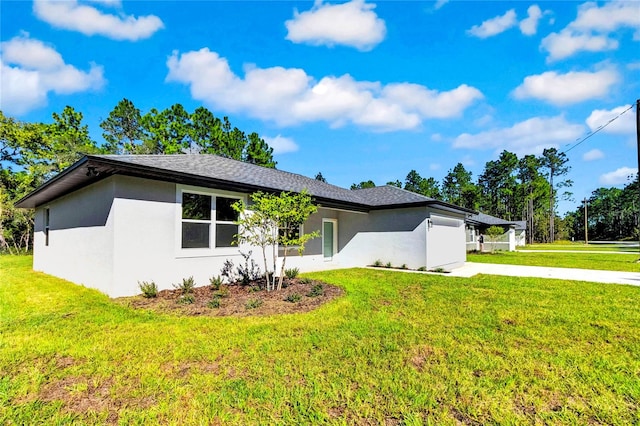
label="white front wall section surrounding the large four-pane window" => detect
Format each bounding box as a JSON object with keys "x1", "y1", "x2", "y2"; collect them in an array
[{"x1": 109, "y1": 176, "x2": 264, "y2": 297}]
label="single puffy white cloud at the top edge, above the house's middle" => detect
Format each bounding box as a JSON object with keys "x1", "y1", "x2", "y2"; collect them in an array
[{"x1": 285, "y1": 0, "x2": 387, "y2": 51}]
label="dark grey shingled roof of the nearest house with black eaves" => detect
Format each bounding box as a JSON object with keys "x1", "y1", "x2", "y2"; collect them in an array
[{"x1": 17, "y1": 154, "x2": 474, "y2": 213}]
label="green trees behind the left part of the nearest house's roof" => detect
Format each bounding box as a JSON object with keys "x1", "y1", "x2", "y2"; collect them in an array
[{"x1": 0, "y1": 99, "x2": 277, "y2": 253}]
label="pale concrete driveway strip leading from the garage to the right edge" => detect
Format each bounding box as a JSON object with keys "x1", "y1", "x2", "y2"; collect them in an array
[{"x1": 447, "y1": 262, "x2": 640, "y2": 286}]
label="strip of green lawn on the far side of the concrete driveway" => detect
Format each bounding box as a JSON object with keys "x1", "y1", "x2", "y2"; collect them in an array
[{"x1": 467, "y1": 251, "x2": 640, "y2": 272}]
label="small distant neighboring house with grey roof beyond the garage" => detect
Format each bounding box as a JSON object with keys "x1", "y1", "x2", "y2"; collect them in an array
[{"x1": 466, "y1": 213, "x2": 527, "y2": 251}]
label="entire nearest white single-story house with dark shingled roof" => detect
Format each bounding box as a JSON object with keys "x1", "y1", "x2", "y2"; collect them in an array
[{"x1": 17, "y1": 155, "x2": 474, "y2": 297}]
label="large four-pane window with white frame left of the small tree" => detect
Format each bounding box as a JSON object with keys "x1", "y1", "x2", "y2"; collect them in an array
[{"x1": 181, "y1": 191, "x2": 238, "y2": 249}]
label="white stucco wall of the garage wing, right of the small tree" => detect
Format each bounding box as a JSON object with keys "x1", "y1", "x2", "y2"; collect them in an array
[{"x1": 287, "y1": 207, "x2": 466, "y2": 271}]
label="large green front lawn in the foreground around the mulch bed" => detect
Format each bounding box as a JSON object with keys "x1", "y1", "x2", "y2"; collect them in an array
[{"x1": 0, "y1": 256, "x2": 640, "y2": 425}]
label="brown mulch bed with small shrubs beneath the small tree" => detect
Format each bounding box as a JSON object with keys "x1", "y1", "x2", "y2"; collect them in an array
[{"x1": 116, "y1": 278, "x2": 344, "y2": 317}]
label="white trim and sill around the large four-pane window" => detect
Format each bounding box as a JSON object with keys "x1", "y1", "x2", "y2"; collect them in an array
[{"x1": 174, "y1": 184, "x2": 247, "y2": 258}]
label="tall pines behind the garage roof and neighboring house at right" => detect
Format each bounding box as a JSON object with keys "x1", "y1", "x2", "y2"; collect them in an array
[{"x1": 351, "y1": 148, "x2": 573, "y2": 243}]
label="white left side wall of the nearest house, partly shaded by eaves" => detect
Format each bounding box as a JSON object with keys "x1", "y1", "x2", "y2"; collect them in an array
[{"x1": 33, "y1": 178, "x2": 115, "y2": 294}]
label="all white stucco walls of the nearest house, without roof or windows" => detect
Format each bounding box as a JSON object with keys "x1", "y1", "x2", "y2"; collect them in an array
[{"x1": 34, "y1": 175, "x2": 466, "y2": 297}]
